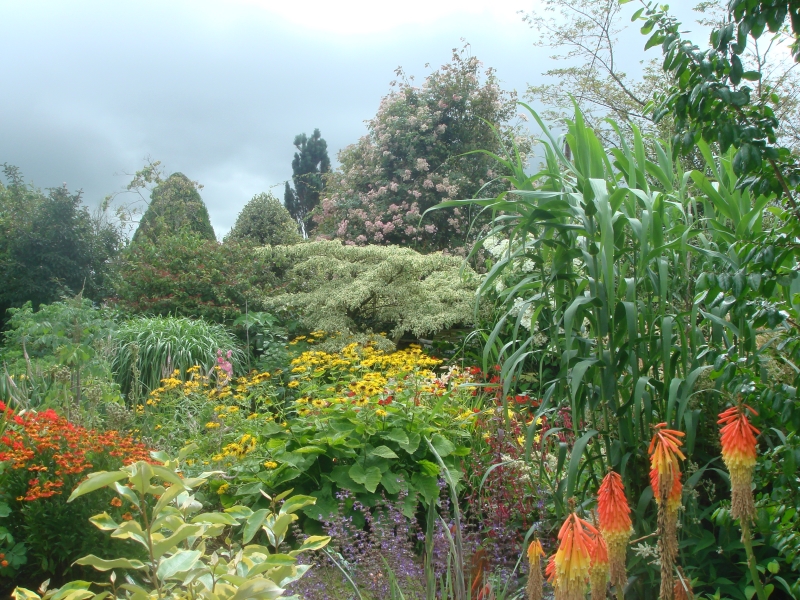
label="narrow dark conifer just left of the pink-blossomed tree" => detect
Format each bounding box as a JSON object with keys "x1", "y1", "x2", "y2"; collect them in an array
[{"x1": 283, "y1": 129, "x2": 331, "y2": 237}]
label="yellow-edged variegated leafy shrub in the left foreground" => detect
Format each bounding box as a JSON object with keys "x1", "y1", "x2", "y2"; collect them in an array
[{"x1": 14, "y1": 452, "x2": 330, "y2": 600}]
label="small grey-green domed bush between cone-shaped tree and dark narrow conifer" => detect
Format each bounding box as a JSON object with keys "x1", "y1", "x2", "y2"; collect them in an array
[{"x1": 225, "y1": 193, "x2": 303, "y2": 246}]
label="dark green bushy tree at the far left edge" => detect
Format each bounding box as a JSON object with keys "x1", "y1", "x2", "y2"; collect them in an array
[{"x1": 0, "y1": 165, "x2": 122, "y2": 320}]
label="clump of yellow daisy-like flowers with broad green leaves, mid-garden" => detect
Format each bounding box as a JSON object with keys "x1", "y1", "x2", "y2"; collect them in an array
[{"x1": 138, "y1": 332, "x2": 477, "y2": 528}]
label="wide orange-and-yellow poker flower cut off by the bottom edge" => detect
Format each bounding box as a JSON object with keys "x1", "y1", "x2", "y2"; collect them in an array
[{"x1": 548, "y1": 513, "x2": 599, "y2": 600}]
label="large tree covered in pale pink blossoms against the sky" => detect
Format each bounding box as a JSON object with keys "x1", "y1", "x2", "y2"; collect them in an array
[{"x1": 313, "y1": 48, "x2": 530, "y2": 253}]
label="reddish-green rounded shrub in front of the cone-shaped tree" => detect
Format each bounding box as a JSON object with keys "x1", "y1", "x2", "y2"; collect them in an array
[{"x1": 111, "y1": 230, "x2": 271, "y2": 322}]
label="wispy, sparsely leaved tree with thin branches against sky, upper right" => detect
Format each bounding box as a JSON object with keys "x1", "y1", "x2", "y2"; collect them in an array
[{"x1": 525, "y1": 0, "x2": 800, "y2": 155}]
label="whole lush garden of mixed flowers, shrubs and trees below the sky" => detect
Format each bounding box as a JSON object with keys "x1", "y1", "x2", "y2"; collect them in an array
[{"x1": 0, "y1": 0, "x2": 800, "y2": 600}]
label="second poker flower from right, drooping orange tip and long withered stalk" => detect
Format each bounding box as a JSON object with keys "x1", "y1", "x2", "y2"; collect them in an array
[{"x1": 648, "y1": 423, "x2": 686, "y2": 600}]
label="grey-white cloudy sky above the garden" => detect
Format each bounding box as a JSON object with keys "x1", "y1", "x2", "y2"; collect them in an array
[{"x1": 0, "y1": 0, "x2": 700, "y2": 238}]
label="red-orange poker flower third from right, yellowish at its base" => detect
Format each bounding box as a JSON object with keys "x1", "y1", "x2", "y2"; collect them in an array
[{"x1": 597, "y1": 471, "x2": 631, "y2": 590}]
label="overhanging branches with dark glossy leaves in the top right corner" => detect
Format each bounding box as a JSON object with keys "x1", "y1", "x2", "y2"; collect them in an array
[{"x1": 634, "y1": 1, "x2": 800, "y2": 200}]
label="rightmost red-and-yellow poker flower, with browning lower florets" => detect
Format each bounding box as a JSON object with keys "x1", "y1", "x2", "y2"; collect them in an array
[{"x1": 717, "y1": 404, "x2": 761, "y2": 521}]
